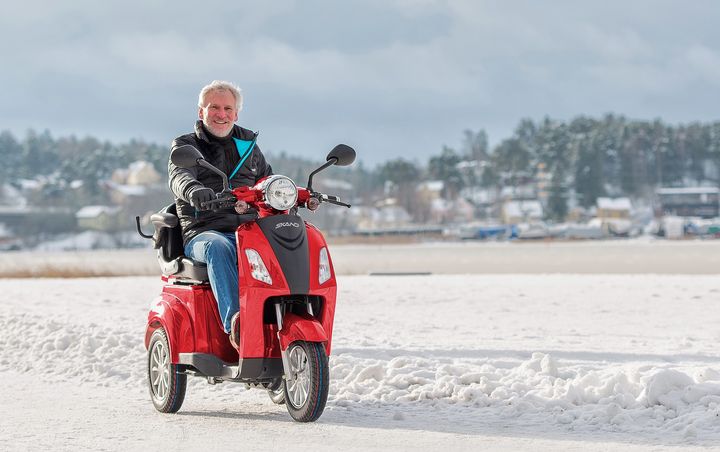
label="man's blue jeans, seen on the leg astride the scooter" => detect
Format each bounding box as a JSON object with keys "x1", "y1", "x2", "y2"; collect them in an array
[{"x1": 185, "y1": 231, "x2": 240, "y2": 333}]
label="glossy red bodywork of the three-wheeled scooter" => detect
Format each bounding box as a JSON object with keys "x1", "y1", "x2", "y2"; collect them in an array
[{"x1": 145, "y1": 222, "x2": 337, "y2": 363}]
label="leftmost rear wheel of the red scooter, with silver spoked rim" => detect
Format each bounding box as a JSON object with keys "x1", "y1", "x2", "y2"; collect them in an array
[{"x1": 147, "y1": 328, "x2": 187, "y2": 413}]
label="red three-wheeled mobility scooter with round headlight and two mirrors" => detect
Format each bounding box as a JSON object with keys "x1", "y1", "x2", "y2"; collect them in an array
[{"x1": 136, "y1": 144, "x2": 355, "y2": 422}]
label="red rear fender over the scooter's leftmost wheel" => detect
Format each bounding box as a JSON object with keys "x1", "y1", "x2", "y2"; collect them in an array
[{"x1": 145, "y1": 293, "x2": 195, "y2": 364}]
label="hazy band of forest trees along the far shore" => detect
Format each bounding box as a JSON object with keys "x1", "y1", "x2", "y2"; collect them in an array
[{"x1": 0, "y1": 115, "x2": 720, "y2": 220}]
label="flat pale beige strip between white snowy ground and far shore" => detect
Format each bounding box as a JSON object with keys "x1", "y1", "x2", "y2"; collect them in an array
[{"x1": 0, "y1": 239, "x2": 720, "y2": 278}]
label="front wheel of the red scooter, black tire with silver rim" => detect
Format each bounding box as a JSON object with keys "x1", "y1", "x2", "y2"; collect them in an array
[{"x1": 283, "y1": 341, "x2": 330, "y2": 422}]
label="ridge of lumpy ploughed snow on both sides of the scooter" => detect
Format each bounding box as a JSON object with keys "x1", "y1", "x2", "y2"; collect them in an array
[{"x1": 0, "y1": 315, "x2": 720, "y2": 439}]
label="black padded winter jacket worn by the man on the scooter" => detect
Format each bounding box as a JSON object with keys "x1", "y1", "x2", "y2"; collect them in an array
[{"x1": 168, "y1": 121, "x2": 272, "y2": 244}]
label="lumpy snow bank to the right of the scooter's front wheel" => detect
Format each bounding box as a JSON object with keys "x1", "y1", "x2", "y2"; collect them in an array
[{"x1": 331, "y1": 353, "x2": 720, "y2": 438}]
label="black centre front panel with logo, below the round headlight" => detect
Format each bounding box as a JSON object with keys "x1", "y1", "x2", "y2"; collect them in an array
[{"x1": 257, "y1": 215, "x2": 310, "y2": 294}]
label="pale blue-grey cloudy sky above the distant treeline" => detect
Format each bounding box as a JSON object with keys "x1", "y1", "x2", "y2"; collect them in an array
[{"x1": 0, "y1": 0, "x2": 720, "y2": 166}]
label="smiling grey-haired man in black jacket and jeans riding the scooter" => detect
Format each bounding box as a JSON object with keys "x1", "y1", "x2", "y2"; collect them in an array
[{"x1": 168, "y1": 80, "x2": 272, "y2": 348}]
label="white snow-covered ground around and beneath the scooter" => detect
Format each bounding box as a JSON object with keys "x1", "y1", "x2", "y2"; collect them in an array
[{"x1": 0, "y1": 273, "x2": 720, "y2": 451}]
